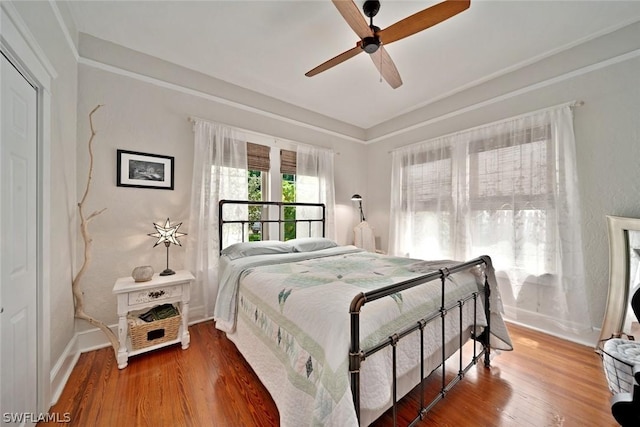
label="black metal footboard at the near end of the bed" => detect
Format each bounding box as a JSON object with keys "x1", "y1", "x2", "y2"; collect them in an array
[{"x1": 349, "y1": 256, "x2": 491, "y2": 426}]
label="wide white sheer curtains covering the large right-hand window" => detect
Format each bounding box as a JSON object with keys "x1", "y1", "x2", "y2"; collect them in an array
[{"x1": 389, "y1": 105, "x2": 591, "y2": 334}]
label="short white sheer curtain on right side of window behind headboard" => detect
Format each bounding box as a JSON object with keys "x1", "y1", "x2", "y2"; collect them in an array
[{"x1": 296, "y1": 145, "x2": 336, "y2": 240}]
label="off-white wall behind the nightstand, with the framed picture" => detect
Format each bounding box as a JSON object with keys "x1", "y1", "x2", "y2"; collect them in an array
[{"x1": 76, "y1": 52, "x2": 366, "y2": 329}]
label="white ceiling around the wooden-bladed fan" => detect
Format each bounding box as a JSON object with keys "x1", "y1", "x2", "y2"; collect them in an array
[{"x1": 63, "y1": 0, "x2": 640, "y2": 129}]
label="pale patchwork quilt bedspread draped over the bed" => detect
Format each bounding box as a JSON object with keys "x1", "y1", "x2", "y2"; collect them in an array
[{"x1": 216, "y1": 248, "x2": 510, "y2": 426}]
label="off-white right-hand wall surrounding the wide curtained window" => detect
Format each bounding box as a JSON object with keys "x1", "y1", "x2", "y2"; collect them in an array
[{"x1": 367, "y1": 24, "x2": 640, "y2": 344}]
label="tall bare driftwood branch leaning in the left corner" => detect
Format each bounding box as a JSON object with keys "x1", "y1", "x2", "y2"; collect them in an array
[{"x1": 71, "y1": 105, "x2": 120, "y2": 356}]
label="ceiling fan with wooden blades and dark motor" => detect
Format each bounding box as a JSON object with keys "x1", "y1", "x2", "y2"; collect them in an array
[{"x1": 305, "y1": 0, "x2": 471, "y2": 89}]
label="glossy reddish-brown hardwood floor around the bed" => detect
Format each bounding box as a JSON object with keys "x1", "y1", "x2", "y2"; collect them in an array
[{"x1": 38, "y1": 322, "x2": 617, "y2": 427}]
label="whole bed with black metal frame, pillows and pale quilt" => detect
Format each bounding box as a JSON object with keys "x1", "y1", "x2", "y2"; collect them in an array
[{"x1": 214, "y1": 200, "x2": 512, "y2": 426}]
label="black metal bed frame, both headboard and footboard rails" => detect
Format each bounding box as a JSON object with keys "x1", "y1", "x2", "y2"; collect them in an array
[{"x1": 218, "y1": 200, "x2": 491, "y2": 426}]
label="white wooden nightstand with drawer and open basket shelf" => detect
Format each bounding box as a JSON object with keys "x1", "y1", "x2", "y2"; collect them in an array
[{"x1": 113, "y1": 270, "x2": 194, "y2": 369}]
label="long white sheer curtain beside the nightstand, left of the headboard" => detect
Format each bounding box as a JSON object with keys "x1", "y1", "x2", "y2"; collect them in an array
[{"x1": 186, "y1": 120, "x2": 248, "y2": 317}]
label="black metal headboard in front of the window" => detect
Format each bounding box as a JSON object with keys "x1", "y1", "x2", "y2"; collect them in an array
[{"x1": 218, "y1": 200, "x2": 326, "y2": 250}]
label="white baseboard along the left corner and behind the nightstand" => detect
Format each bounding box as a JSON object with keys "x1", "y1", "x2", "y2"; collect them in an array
[{"x1": 49, "y1": 306, "x2": 211, "y2": 406}]
